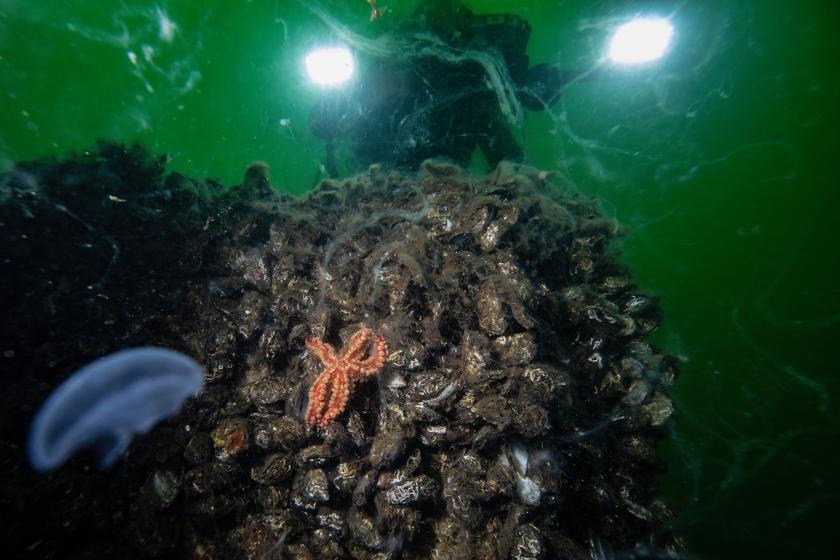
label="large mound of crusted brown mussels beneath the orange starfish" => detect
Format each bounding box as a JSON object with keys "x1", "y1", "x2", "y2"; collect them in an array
[{"x1": 0, "y1": 145, "x2": 681, "y2": 560}]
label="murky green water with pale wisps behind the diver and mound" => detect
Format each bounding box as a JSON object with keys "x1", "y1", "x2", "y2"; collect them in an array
[{"x1": 0, "y1": 0, "x2": 840, "y2": 558}]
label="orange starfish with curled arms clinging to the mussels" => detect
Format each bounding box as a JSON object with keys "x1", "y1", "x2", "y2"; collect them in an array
[{"x1": 306, "y1": 327, "x2": 388, "y2": 428}]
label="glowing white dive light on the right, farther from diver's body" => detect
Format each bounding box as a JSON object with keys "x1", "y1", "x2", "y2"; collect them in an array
[{"x1": 607, "y1": 18, "x2": 674, "y2": 64}]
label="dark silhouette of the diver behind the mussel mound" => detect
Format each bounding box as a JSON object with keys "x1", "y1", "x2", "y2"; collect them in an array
[{"x1": 309, "y1": 0, "x2": 584, "y2": 177}]
